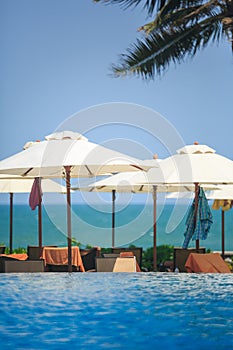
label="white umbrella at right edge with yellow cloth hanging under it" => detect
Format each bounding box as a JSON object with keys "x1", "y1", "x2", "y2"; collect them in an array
[{"x1": 207, "y1": 185, "x2": 233, "y2": 258}]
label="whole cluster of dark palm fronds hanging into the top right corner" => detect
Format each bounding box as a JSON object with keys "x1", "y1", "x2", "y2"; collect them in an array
[{"x1": 96, "y1": 0, "x2": 233, "y2": 79}]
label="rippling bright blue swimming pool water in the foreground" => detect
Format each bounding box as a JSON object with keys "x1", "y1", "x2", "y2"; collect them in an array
[{"x1": 0, "y1": 272, "x2": 233, "y2": 350}]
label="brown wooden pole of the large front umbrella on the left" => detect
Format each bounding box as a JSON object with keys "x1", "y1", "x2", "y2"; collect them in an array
[{"x1": 65, "y1": 166, "x2": 72, "y2": 272}]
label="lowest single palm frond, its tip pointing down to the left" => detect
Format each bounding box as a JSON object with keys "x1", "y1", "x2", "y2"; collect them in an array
[{"x1": 112, "y1": 16, "x2": 222, "y2": 79}]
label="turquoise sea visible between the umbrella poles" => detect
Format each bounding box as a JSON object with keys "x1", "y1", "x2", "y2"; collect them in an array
[{"x1": 0, "y1": 204, "x2": 233, "y2": 251}]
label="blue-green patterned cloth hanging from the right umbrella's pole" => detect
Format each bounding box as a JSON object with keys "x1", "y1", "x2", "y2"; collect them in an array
[{"x1": 183, "y1": 188, "x2": 213, "y2": 249}]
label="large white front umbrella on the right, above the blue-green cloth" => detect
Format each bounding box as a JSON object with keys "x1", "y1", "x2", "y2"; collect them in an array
[{"x1": 141, "y1": 143, "x2": 233, "y2": 253}]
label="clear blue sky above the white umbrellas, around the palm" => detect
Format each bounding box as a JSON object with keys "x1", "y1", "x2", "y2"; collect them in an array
[{"x1": 0, "y1": 0, "x2": 233, "y2": 205}]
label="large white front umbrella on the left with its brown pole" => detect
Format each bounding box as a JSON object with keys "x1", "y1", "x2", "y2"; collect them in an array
[{"x1": 0, "y1": 131, "x2": 150, "y2": 272}]
